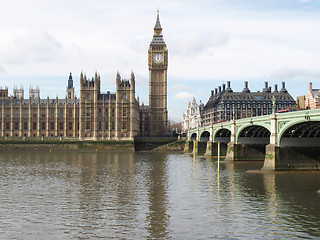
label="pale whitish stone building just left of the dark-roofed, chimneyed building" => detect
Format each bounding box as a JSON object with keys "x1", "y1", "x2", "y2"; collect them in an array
[{"x1": 182, "y1": 97, "x2": 203, "y2": 133}]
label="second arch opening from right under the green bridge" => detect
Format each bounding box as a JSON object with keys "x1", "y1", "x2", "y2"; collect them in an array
[{"x1": 236, "y1": 124, "x2": 271, "y2": 145}]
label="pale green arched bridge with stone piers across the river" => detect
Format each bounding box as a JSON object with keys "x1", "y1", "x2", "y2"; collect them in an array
[{"x1": 186, "y1": 109, "x2": 320, "y2": 170}]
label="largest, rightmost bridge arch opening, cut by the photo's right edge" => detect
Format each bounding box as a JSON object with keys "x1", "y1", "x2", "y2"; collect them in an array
[{"x1": 278, "y1": 119, "x2": 320, "y2": 147}]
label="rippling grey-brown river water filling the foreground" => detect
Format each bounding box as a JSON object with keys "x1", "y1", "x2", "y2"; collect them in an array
[{"x1": 0, "y1": 152, "x2": 320, "y2": 240}]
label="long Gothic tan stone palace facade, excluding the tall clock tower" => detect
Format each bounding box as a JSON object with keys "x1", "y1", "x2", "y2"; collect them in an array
[{"x1": 0, "y1": 70, "x2": 140, "y2": 140}]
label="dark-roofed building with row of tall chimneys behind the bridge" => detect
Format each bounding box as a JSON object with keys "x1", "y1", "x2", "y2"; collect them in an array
[{"x1": 202, "y1": 81, "x2": 296, "y2": 125}]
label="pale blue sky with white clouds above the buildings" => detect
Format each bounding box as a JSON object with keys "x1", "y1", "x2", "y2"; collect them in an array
[{"x1": 0, "y1": 0, "x2": 320, "y2": 122}]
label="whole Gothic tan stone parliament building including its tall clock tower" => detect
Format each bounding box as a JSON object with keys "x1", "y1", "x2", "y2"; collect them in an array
[{"x1": 0, "y1": 12, "x2": 168, "y2": 140}]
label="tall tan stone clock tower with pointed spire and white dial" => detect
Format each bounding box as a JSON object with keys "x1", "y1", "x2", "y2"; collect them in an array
[{"x1": 148, "y1": 10, "x2": 168, "y2": 137}]
